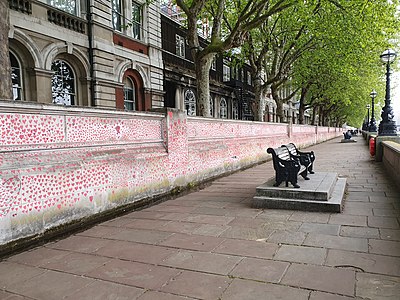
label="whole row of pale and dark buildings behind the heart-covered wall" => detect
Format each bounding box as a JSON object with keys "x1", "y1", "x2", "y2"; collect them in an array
[{"x1": 8, "y1": 0, "x2": 310, "y2": 123}]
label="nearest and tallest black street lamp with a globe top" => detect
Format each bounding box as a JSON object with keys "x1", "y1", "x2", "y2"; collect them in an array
[{"x1": 378, "y1": 49, "x2": 397, "y2": 136}]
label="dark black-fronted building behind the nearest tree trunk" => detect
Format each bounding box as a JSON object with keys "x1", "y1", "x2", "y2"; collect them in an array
[{"x1": 161, "y1": 11, "x2": 254, "y2": 120}]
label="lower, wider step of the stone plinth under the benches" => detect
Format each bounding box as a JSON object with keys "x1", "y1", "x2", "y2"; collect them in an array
[{"x1": 252, "y1": 178, "x2": 346, "y2": 213}]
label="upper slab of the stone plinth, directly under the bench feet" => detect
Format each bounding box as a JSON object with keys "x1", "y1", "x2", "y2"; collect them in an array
[{"x1": 256, "y1": 172, "x2": 338, "y2": 201}]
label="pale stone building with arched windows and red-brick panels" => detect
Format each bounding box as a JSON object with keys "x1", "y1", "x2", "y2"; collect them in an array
[{"x1": 9, "y1": 0, "x2": 163, "y2": 111}]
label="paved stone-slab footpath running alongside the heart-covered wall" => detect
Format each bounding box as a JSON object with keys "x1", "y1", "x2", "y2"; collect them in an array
[{"x1": 0, "y1": 138, "x2": 400, "y2": 300}]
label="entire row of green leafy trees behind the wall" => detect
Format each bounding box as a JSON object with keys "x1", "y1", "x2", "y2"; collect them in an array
[{"x1": 176, "y1": 0, "x2": 399, "y2": 126}]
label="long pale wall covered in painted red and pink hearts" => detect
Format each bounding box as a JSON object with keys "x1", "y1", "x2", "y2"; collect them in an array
[{"x1": 0, "y1": 103, "x2": 342, "y2": 245}]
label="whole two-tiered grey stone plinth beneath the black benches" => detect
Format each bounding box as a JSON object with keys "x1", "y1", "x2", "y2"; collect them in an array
[{"x1": 252, "y1": 172, "x2": 346, "y2": 212}]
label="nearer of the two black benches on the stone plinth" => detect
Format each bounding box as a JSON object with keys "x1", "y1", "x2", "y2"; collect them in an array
[{"x1": 267, "y1": 147, "x2": 309, "y2": 188}]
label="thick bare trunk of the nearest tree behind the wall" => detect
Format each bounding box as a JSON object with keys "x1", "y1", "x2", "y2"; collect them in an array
[{"x1": 195, "y1": 54, "x2": 214, "y2": 117}]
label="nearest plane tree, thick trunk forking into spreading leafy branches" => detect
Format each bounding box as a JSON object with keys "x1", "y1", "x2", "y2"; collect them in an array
[{"x1": 176, "y1": 0, "x2": 297, "y2": 117}]
